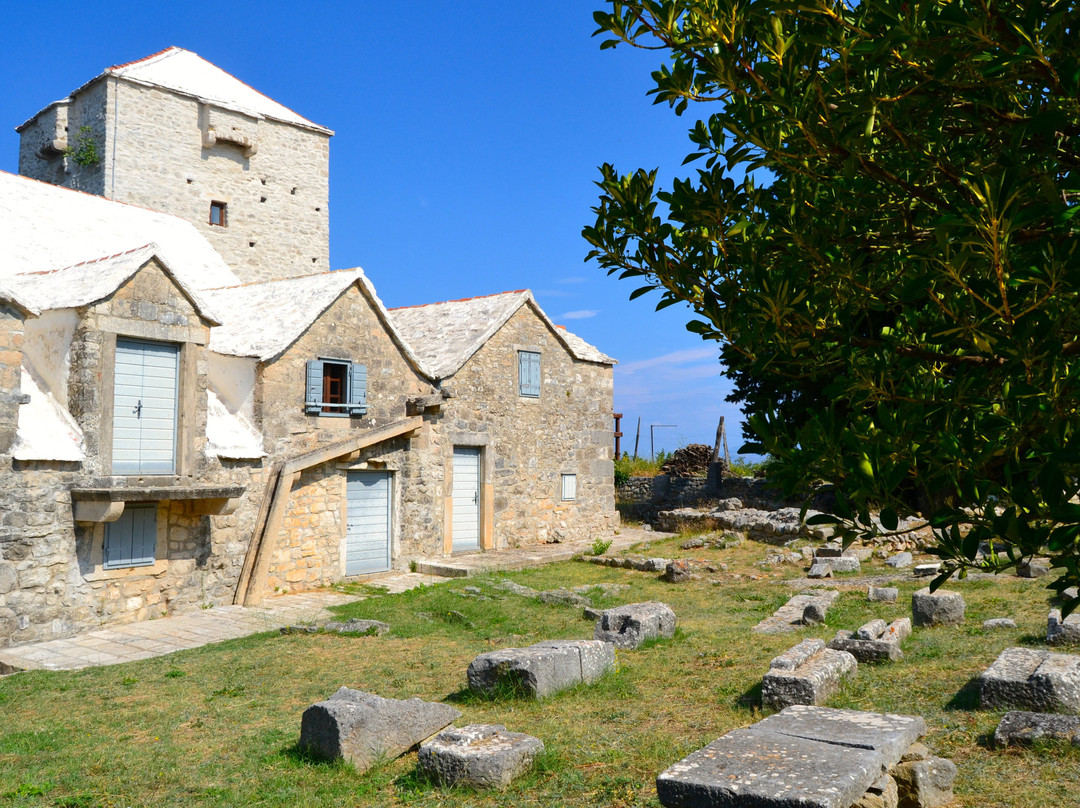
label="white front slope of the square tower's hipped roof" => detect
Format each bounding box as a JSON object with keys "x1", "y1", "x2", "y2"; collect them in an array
[{"x1": 105, "y1": 48, "x2": 333, "y2": 134}]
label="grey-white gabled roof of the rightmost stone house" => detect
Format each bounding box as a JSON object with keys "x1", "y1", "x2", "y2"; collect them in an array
[{"x1": 390, "y1": 289, "x2": 616, "y2": 379}]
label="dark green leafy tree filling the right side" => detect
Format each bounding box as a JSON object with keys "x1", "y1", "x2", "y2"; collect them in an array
[{"x1": 583, "y1": 0, "x2": 1080, "y2": 608}]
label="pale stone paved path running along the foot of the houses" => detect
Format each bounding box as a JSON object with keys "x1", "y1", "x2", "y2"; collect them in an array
[{"x1": 0, "y1": 528, "x2": 667, "y2": 675}]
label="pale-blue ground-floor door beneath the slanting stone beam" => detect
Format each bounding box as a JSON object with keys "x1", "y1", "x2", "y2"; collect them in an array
[{"x1": 345, "y1": 471, "x2": 392, "y2": 575}]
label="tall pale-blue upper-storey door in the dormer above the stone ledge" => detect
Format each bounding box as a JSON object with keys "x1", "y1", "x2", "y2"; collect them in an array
[{"x1": 112, "y1": 339, "x2": 180, "y2": 474}]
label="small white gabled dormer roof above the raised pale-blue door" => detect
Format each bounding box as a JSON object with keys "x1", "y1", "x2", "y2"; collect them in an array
[{"x1": 0, "y1": 244, "x2": 220, "y2": 325}]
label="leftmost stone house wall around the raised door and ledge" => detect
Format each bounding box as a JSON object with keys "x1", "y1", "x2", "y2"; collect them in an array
[{"x1": 0, "y1": 261, "x2": 255, "y2": 646}]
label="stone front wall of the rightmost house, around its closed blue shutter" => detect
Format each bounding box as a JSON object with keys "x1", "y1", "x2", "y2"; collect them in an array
[{"x1": 441, "y1": 306, "x2": 618, "y2": 549}]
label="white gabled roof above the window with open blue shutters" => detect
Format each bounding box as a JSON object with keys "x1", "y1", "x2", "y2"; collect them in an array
[{"x1": 206, "y1": 267, "x2": 428, "y2": 375}]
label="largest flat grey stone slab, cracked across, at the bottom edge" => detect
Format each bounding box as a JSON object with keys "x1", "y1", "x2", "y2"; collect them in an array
[{"x1": 657, "y1": 706, "x2": 926, "y2": 808}]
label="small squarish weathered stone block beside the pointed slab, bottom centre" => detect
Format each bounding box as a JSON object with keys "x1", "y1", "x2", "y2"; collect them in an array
[{"x1": 418, "y1": 724, "x2": 543, "y2": 789}]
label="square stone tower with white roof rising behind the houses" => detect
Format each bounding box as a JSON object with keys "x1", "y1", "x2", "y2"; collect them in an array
[{"x1": 17, "y1": 48, "x2": 334, "y2": 282}]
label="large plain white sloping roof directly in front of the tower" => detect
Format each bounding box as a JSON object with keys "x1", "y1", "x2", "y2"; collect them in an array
[{"x1": 0, "y1": 172, "x2": 240, "y2": 289}]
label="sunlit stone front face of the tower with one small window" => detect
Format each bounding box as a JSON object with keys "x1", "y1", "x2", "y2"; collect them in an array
[{"x1": 107, "y1": 82, "x2": 330, "y2": 282}]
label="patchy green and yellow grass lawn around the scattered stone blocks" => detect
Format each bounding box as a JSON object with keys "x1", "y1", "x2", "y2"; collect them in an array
[{"x1": 0, "y1": 540, "x2": 1080, "y2": 808}]
